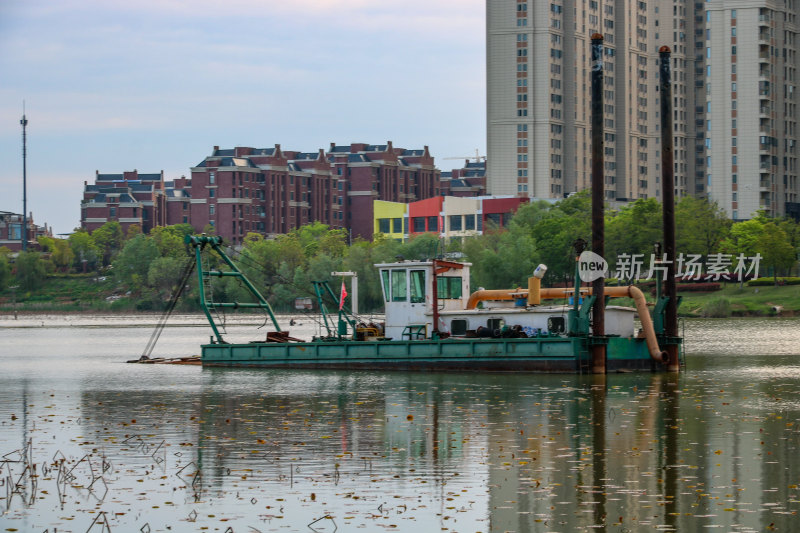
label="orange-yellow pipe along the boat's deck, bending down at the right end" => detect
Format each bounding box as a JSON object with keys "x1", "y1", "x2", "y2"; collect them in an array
[{"x1": 467, "y1": 282, "x2": 667, "y2": 362}]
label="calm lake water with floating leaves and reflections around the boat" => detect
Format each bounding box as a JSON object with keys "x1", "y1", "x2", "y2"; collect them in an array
[{"x1": 0, "y1": 316, "x2": 800, "y2": 533}]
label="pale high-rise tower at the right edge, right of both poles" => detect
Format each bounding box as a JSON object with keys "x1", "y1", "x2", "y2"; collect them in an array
[{"x1": 705, "y1": 0, "x2": 800, "y2": 220}]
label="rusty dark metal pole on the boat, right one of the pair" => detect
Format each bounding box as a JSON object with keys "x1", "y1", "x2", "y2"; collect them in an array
[{"x1": 658, "y1": 46, "x2": 680, "y2": 372}]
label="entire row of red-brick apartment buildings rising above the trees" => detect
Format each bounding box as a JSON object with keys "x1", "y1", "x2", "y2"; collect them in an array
[{"x1": 81, "y1": 141, "x2": 441, "y2": 244}]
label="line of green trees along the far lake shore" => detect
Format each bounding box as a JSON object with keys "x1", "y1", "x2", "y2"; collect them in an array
[{"x1": 0, "y1": 193, "x2": 800, "y2": 312}]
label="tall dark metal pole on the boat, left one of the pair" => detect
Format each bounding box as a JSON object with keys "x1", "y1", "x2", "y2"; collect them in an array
[{"x1": 588, "y1": 33, "x2": 606, "y2": 374}]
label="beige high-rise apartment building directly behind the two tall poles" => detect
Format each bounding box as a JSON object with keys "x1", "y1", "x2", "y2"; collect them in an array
[{"x1": 486, "y1": 0, "x2": 705, "y2": 201}]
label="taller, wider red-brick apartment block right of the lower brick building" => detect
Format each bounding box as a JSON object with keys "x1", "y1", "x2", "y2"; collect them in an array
[{"x1": 189, "y1": 141, "x2": 440, "y2": 243}]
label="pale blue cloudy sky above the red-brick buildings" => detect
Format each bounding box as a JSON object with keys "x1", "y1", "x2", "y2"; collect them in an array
[{"x1": 0, "y1": 0, "x2": 486, "y2": 233}]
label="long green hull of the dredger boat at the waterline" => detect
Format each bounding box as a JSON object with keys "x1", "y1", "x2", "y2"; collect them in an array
[{"x1": 201, "y1": 337, "x2": 662, "y2": 373}]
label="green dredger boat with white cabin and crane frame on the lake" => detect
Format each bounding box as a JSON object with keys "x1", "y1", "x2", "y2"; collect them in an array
[{"x1": 186, "y1": 235, "x2": 682, "y2": 373}]
